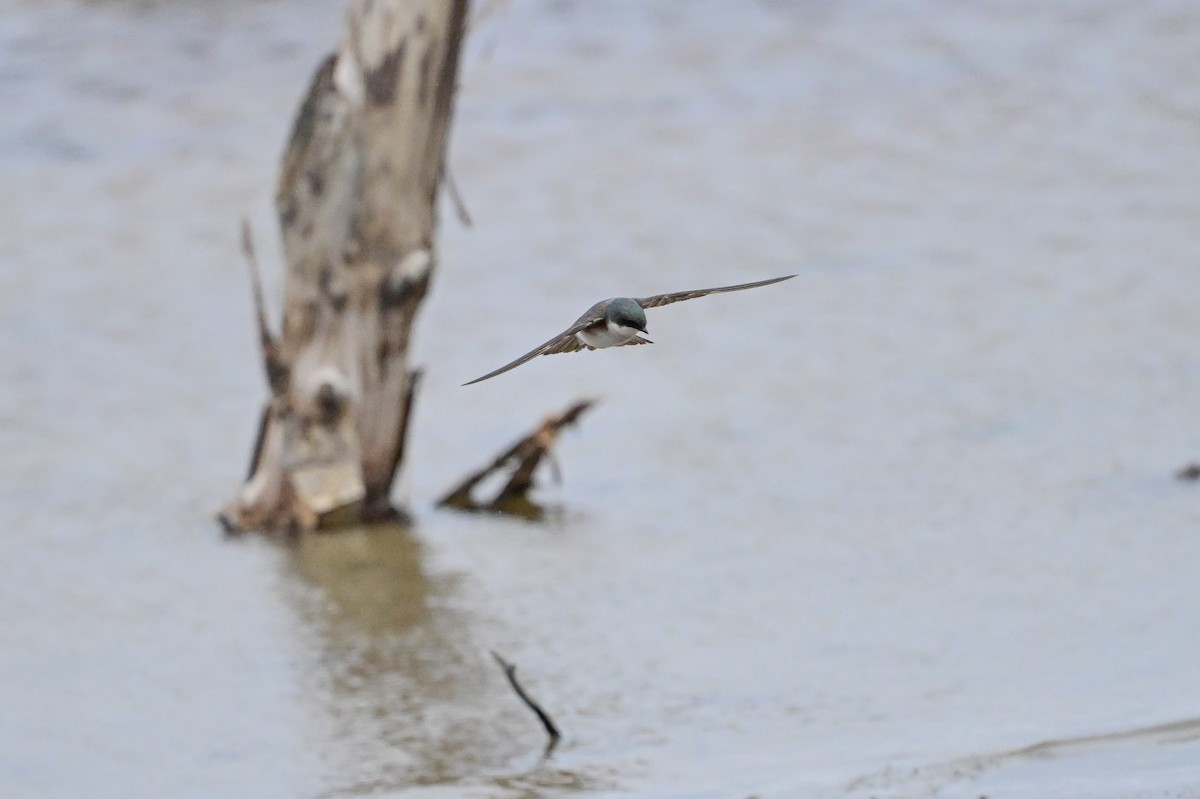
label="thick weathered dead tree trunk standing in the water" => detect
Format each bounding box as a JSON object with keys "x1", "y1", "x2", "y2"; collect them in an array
[{"x1": 221, "y1": 0, "x2": 468, "y2": 530}]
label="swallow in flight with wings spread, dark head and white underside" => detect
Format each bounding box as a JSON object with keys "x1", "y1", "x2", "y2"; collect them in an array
[{"x1": 463, "y1": 275, "x2": 796, "y2": 385}]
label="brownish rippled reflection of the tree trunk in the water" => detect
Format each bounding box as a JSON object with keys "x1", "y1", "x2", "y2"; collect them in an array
[{"x1": 288, "y1": 525, "x2": 526, "y2": 793}]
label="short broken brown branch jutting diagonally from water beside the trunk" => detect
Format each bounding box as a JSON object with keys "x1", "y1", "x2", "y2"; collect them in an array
[{"x1": 438, "y1": 400, "x2": 594, "y2": 521}]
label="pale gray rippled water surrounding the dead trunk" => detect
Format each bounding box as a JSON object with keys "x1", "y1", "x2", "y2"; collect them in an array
[{"x1": 7, "y1": 0, "x2": 1200, "y2": 799}]
